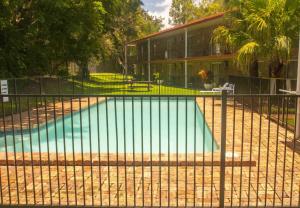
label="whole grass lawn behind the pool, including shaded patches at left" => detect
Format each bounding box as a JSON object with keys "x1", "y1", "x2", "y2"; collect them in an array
[{"x1": 0, "y1": 73, "x2": 216, "y2": 116}]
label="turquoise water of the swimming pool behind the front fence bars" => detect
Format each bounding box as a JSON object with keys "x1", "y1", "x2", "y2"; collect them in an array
[{"x1": 0, "y1": 98, "x2": 218, "y2": 153}]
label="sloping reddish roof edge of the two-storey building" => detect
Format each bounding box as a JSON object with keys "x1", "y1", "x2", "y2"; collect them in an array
[{"x1": 128, "y1": 12, "x2": 225, "y2": 44}]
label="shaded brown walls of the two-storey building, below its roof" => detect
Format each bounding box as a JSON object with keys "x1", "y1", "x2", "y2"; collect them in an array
[{"x1": 135, "y1": 18, "x2": 298, "y2": 88}]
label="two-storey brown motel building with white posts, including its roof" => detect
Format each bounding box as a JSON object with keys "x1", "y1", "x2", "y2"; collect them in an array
[{"x1": 125, "y1": 13, "x2": 298, "y2": 94}]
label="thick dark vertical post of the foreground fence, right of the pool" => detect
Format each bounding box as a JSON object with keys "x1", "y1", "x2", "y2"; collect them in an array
[{"x1": 219, "y1": 91, "x2": 227, "y2": 208}]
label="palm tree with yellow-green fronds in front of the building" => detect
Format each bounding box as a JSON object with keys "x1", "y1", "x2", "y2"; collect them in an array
[{"x1": 213, "y1": 0, "x2": 300, "y2": 77}]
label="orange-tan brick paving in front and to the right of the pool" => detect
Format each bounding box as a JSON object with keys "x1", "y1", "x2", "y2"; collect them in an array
[{"x1": 0, "y1": 98, "x2": 300, "y2": 207}]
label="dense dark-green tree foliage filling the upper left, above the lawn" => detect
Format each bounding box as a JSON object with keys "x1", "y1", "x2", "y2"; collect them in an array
[{"x1": 0, "y1": 0, "x2": 161, "y2": 77}]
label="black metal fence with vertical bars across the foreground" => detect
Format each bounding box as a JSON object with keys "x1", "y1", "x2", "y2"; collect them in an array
[{"x1": 0, "y1": 93, "x2": 300, "y2": 207}]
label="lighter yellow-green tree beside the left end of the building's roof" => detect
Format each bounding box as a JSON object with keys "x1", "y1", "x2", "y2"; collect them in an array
[{"x1": 101, "y1": 0, "x2": 162, "y2": 71}]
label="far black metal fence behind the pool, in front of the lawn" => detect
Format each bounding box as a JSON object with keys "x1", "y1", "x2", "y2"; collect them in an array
[{"x1": 2, "y1": 73, "x2": 199, "y2": 95}]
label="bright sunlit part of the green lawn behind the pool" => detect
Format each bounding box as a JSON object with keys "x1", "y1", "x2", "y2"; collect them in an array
[{"x1": 44, "y1": 73, "x2": 215, "y2": 95}]
